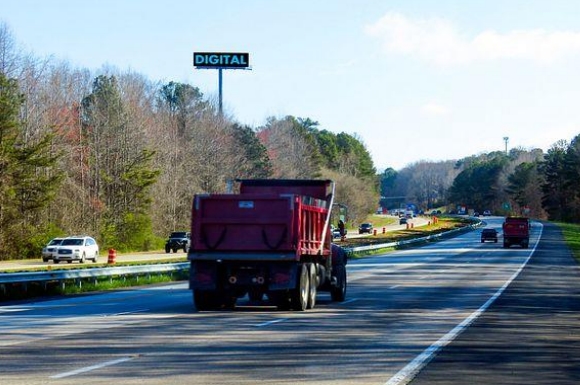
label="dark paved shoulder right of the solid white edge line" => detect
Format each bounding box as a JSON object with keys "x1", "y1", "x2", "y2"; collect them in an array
[{"x1": 412, "y1": 224, "x2": 580, "y2": 385}]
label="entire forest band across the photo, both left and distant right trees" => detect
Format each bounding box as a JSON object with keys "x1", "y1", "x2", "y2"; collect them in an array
[{"x1": 0, "y1": 23, "x2": 580, "y2": 260}]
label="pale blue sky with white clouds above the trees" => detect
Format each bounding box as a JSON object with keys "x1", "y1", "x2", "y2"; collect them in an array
[{"x1": 0, "y1": 0, "x2": 580, "y2": 170}]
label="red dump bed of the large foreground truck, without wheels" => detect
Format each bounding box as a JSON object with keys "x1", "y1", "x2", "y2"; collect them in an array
[{"x1": 190, "y1": 181, "x2": 330, "y2": 260}]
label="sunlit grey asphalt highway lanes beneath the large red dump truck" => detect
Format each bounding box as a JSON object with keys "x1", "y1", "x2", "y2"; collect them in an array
[{"x1": 0, "y1": 218, "x2": 566, "y2": 384}]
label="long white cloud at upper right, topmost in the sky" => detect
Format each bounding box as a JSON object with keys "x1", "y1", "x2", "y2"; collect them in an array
[{"x1": 365, "y1": 12, "x2": 580, "y2": 66}]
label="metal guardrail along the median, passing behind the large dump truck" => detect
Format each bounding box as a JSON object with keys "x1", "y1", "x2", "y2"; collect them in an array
[{"x1": 0, "y1": 222, "x2": 481, "y2": 285}]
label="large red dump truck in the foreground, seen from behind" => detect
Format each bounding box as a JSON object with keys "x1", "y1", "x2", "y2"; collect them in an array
[{"x1": 188, "y1": 179, "x2": 347, "y2": 311}]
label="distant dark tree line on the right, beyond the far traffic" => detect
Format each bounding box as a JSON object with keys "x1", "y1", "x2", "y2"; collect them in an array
[{"x1": 380, "y1": 140, "x2": 580, "y2": 223}]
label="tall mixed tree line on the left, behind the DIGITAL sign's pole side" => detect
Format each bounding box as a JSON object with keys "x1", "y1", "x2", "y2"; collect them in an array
[{"x1": 0, "y1": 23, "x2": 378, "y2": 259}]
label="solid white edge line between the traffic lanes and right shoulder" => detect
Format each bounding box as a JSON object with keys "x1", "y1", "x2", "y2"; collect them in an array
[{"x1": 384, "y1": 223, "x2": 544, "y2": 385}]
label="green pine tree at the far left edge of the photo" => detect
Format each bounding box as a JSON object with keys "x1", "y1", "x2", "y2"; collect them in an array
[{"x1": 0, "y1": 73, "x2": 62, "y2": 259}]
